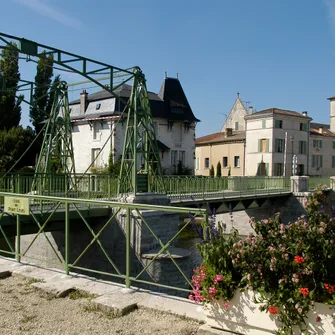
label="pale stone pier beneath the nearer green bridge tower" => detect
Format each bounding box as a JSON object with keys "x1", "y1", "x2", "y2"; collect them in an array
[{"x1": 116, "y1": 193, "x2": 193, "y2": 296}]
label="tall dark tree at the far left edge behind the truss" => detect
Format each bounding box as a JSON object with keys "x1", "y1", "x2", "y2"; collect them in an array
[{"x1": 0, "y1": 43, "x2": 23, "y2": 130}]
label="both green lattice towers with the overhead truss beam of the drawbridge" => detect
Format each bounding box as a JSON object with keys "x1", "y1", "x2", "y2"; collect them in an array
[{"x1": 0, "y1": 33, "x2": 163, "y2": 194}]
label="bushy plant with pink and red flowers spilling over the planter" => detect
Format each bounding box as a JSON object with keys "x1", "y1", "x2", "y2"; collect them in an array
[{"x1": 191, "y1": 187, "x2": 335, "y2": 334}]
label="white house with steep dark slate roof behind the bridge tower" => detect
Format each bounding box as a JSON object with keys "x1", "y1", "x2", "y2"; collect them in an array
[{"x1": 70, "y1": 78, "x2": 199, "y2": 174}]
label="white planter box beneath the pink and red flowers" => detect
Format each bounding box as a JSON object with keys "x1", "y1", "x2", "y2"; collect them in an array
[{"x1": 204, "y1": 291, "x2": 335, "y2": 335}]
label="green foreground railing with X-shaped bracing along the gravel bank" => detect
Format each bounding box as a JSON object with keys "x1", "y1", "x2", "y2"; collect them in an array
[{"x1": 0, "y1": 192, "x2": 208, "y2": 292}]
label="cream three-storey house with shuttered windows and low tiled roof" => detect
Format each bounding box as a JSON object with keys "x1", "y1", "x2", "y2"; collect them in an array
[{"x1": 245, "y1": 109, "x2": 311, "y2": 176}]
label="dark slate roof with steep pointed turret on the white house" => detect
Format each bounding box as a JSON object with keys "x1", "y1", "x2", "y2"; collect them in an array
[{"x1": 69, "y1": 78, "x2": 200, "y2": 122}]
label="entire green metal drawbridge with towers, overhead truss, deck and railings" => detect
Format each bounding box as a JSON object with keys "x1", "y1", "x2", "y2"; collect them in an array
[{"x1": 0, "y1": 33, "x2": 330, "y2": 292}]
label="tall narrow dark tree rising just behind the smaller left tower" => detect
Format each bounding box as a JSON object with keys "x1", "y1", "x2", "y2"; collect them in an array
[{"x1": 29, "y1": 51, "x2": 57, "y2": 134}]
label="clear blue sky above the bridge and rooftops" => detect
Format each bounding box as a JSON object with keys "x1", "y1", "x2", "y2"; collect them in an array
[{"x1": 0, "y1": 0, "x2": 335, "y2": 137}]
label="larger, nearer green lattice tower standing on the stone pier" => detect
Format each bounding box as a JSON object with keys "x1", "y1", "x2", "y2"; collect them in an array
[{"x1": 118, "y1": 67, "x2": 162, "y2": 194}]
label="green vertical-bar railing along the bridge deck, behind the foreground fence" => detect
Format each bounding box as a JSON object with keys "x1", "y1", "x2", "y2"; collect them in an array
[{"x1": 0, "y1": 174, "x2": 296, "y2": 201}]
